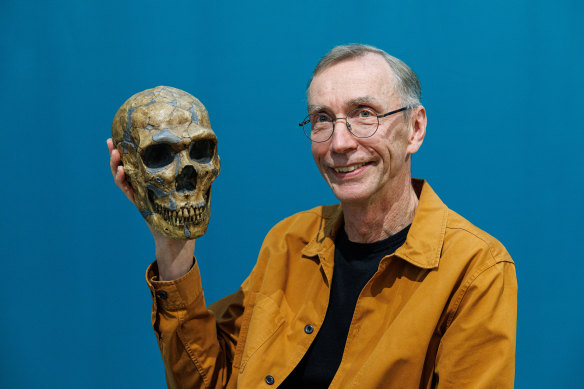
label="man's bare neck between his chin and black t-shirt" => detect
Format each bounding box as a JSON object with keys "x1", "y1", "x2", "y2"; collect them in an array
[{"x1": 343, "y1": 178, "x2": 418, "y2": 243}]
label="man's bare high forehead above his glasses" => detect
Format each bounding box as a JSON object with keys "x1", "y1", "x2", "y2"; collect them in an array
[{"x1": 308, "y1": 53, "x2": 394, "y2": 107}]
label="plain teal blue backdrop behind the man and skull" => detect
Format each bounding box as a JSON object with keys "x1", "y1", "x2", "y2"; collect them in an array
[{"x1": 0, "y1": 0, "x2": 584, "y2": 388}]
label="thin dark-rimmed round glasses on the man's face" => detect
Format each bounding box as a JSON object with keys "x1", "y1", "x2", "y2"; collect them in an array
[{"x1": 298, "y1": 105, "x2": 416, "y2": 143}]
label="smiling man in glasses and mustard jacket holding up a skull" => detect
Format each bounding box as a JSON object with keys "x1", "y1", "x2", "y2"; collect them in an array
[{"x1": 110, "y1": 45, "x2": 517, "y2": 388}]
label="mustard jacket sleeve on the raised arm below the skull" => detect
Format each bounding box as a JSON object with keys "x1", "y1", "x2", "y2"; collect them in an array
[{"x1": 146, "y1": 261, "x2": 247, "y2": 389}]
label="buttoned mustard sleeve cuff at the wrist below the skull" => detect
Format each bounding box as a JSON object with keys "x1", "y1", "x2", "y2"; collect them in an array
[{"x1": 146, "y1": 259, "x2": 203, "y2": 311}]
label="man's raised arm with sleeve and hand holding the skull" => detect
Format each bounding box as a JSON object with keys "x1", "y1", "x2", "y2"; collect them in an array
[{"x1": 107, "y1": 139, "x2": 244, "y2": 388}]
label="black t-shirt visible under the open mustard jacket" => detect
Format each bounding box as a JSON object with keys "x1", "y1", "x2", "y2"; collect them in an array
[{"x1": 279, "y1": 226, "x2": 410, "y2": 389}]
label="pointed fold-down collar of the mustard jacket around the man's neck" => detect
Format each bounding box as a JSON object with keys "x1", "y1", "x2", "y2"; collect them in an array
[{"x1": 302, "y1": 178, "x2": 448, "y2": 269}]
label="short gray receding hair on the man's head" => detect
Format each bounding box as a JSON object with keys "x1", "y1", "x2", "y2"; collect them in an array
[{"x1": 306, "y1": 43, "x2": 422, "y2": 110}]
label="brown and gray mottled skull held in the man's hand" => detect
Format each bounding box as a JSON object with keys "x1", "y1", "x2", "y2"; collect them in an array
[{"x1": 112, "y1": 86, "x2": 220, "y2": 239}]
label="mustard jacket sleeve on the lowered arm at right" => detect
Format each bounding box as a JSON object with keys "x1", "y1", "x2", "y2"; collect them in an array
[{"x1": 434, "y1": 260, "x2": 517, "y2": 389}]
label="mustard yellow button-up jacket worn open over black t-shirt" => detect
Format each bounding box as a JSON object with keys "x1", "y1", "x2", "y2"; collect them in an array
[{"x1": 147, "y1": 180, "x2": 517, "y2": 389}]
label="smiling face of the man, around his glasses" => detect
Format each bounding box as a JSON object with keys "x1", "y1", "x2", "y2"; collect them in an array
[{"x1": 309, "y1": 54, "x2": 425, "y2": 209}]
